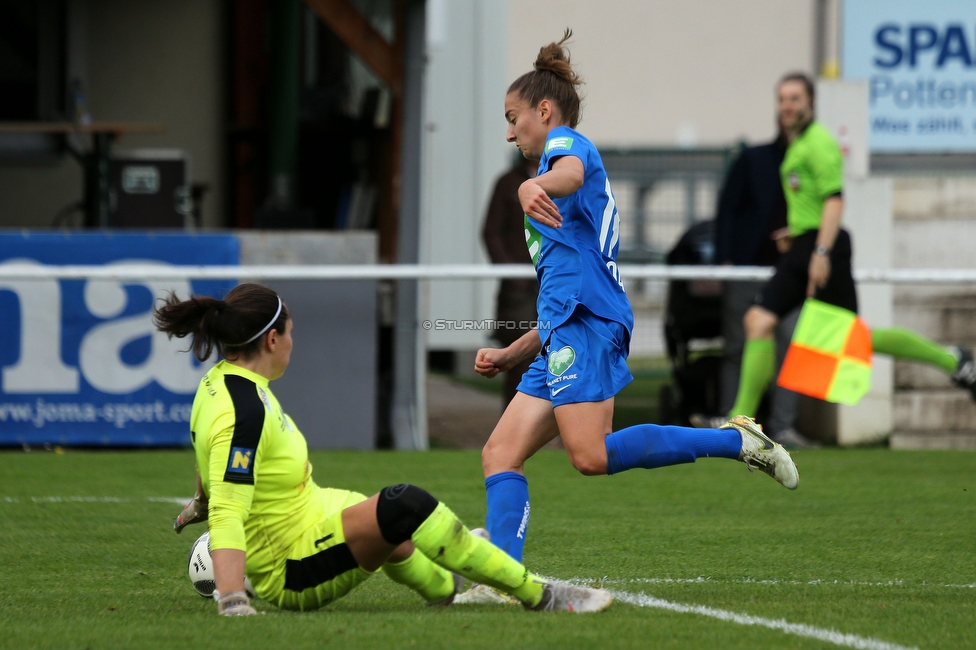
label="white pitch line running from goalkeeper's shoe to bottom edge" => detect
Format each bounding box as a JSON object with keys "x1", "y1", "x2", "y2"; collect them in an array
[{"x1": 610, "y1": 590, "x2": 917, "y2": 650}]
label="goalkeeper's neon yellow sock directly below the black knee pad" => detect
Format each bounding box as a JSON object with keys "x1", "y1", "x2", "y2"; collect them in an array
[{"x1": 411, "y1": 503, "x2": 544, "y2": 607}]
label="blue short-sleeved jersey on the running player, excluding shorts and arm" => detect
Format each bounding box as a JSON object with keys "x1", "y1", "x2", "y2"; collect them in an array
[{"x1": 524, "y1": 126, "x2": 634, "y2": 343}]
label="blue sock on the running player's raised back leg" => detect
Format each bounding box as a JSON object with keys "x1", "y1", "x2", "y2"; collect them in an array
[{"x1": 606, "y1": 424, "x2": 742, "y2": 474}]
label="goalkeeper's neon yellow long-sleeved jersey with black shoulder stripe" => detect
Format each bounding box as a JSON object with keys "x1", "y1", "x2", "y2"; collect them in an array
[{"x1": 190, "y1": 361, "x2": 324, "y2": 584}]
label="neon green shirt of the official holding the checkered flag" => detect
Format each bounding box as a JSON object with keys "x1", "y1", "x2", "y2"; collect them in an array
[{"x1": 779, "y1": 121, "x2": 844, "y2": 237}]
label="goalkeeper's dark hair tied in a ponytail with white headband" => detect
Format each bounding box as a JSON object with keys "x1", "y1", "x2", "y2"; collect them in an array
[{"x1": 153, "y1": 284, "x2": 289, "y2": 361}]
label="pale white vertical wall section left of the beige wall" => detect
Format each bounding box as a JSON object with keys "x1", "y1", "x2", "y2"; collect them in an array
[{"x1": 420, "y1": 0, "x2": 512, "y2": 349}]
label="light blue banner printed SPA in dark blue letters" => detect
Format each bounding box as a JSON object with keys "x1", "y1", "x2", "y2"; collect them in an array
[{"x1": 841, "y1": 0, "x2": 976, "y2": 153}]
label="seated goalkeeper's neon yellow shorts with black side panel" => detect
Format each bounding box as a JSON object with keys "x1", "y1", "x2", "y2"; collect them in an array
[{"x1": 259, "y1": 488, "x2": 373, "y2": 610}]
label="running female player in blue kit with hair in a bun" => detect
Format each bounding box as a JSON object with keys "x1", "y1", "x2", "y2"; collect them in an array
[{"x1": 475, "y1": 30, "x2": 798, "y2": 560}]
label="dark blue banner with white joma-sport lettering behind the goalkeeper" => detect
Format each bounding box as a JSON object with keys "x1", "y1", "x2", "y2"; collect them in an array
[{"x1": 0, "y1": 233, "x2": 239, "y2": 446}]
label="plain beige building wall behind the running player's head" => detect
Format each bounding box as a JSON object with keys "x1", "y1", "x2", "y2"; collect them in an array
[{"x1": 508, "y1": 0, "x2": 816, "y2": 147}]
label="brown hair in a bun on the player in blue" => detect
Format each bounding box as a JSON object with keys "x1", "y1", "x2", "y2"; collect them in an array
[{"x1": 508, "y1": 28, "x2": 583, "y2": 129}]
